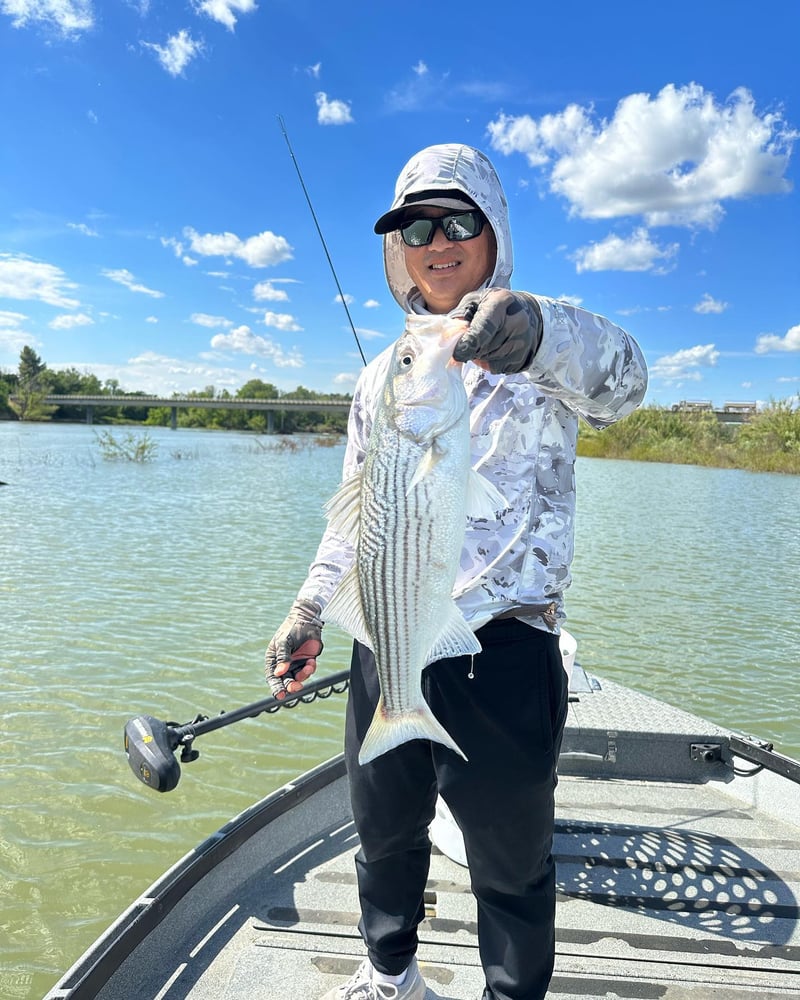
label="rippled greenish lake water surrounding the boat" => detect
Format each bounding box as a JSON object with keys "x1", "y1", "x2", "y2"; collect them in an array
[{"x1": 0, "y1": 423, "x2": 800, "y2": 1000}]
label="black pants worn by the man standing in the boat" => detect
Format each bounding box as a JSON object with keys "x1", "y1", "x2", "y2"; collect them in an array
[{"x1": 345, "y1": 619, "x2": 567, "y2": 1000}]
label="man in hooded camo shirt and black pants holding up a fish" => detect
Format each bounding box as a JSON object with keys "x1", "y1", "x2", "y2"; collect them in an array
[{"x1": 266, "y1": 144, "x2": 647, "y2": 1000}]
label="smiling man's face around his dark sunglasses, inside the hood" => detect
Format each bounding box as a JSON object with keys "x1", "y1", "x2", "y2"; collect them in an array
[{"x1": 403, "y1": 206, "x2": 497, "y2": 314}]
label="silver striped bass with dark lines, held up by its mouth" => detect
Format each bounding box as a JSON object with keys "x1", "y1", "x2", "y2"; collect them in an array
[{"x1": 323, "y1": 315, "x2": 505, "y2": 765}]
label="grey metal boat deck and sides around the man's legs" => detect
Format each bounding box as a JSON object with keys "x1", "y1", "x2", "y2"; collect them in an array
[{"x1": 48, "y1": 678, "x2": 800, "y2": 1000}]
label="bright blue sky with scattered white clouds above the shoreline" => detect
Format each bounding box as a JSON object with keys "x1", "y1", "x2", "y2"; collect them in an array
[{"x1": 0, "y1": 0, "x2": 800, "y2": 405}]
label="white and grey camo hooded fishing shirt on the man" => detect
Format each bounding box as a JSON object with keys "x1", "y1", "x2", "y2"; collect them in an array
[{"x1": 298, "y1": 144, "x2": 647, "y2": 631}]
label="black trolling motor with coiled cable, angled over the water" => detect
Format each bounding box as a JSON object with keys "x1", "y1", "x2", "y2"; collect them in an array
[{"x1": 125, "y1": 670, "x2": 350, "y2": 792}]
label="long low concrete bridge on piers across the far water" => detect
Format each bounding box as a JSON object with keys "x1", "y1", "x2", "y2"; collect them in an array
[{"x1": 32, "y1": 395, "x2": 350, "y2": 434}]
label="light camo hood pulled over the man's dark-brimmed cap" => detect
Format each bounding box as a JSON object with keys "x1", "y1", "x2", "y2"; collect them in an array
[{"x1": 375, "y1": 143, "x2": 514, "y2": 312}]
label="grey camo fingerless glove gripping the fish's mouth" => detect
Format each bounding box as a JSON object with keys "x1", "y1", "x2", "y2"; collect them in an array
[{"x1": 452, "y1": 288, "x2": 542, "y2": 375}]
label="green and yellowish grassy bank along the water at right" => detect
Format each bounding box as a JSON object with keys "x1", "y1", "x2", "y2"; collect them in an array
[{"x1": 578, "y1": 400, "x2": 800, "y2": 474}]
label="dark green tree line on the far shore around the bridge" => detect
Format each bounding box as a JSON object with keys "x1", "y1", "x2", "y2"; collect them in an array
[{"x1": 0, "y1": 346, "x2": 351, "y2": 434}]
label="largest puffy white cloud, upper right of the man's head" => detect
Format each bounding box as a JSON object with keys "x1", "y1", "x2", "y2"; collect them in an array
[{"x1": 488, "y1": 83, "x2": 800, "y2": 227}]
